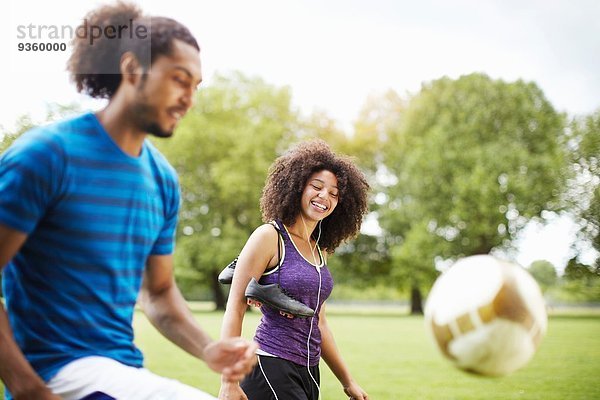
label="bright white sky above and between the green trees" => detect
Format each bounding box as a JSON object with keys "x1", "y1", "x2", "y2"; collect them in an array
[{"x1": 0, "y1": 0, "x2": 600, "y2": 272}]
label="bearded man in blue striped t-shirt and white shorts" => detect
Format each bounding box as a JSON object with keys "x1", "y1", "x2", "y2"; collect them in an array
[{"x1": 0, "y1": 3, "x2": 256, "y2": 400}]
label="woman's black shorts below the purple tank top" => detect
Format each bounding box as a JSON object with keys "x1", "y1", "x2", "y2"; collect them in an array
[{"x1": 240, "y1": 356, "x2": 320, "y2": 400}]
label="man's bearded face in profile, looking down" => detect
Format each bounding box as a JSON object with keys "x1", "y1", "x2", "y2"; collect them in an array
[{"x1": 131, "y1": 40, "x2": 202, "y2": 137}]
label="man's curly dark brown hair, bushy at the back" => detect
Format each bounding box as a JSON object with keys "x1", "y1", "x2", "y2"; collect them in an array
[{"x1": 67, "y1": 1, "x2": 200, "y2": 99}]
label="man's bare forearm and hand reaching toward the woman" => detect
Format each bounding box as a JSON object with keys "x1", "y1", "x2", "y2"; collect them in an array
[{"x1": 140, "y1": 255, "x2": 257, "y2": 380}]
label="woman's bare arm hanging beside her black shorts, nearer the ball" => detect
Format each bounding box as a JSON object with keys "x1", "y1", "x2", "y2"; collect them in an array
[{"x1": 319, "y1": 303, "x2": 369, "y2": 400}]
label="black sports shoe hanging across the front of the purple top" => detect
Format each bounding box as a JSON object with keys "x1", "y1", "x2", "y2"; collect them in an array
[{"x1": 245, "y1": 278, "x2": 315, "y2": 318}]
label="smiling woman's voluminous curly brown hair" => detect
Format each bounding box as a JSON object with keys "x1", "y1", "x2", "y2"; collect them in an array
[{"x1": 260, "y1": 140, "x2": 369, "y2": 253}]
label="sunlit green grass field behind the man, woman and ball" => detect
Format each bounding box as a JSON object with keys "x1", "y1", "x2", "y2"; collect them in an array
[{"x1": 1, "y1": 310, "x2": 600, "y2": 400}]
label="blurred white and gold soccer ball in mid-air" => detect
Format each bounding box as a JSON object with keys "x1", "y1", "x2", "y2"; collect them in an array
[{"x1": 425, "y1": 255, "x2": 548, "y2": 376}]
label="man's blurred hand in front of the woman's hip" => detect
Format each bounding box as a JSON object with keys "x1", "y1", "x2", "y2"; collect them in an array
[{"x1": 203, "y1": 338, "x2": 258, "y2": 382}]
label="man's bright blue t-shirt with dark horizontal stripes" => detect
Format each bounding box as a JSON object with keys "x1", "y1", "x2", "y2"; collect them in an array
[{"x1": 0, "y1": 114, "x2": 180, "y2": 381}]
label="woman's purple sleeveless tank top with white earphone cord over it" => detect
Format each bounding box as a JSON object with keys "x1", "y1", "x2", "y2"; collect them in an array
[{"x1": 254, "y1": 221, "x2": 333, "y2": 366}]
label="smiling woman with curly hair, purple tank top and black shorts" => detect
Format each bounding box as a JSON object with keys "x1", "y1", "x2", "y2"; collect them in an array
[{"x1": 219, "y1": 140, "x2": 369, "y2": 400}]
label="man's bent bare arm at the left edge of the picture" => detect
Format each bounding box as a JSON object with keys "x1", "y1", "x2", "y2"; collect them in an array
[{"x1": 0, "y1": 224, "x2": 60, "y2": 400}]
